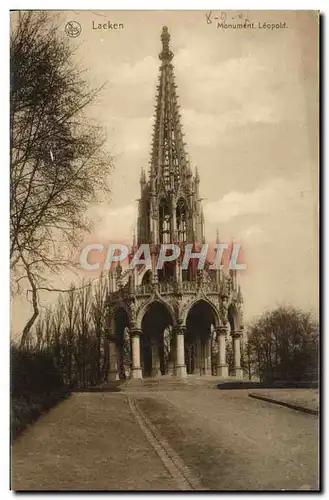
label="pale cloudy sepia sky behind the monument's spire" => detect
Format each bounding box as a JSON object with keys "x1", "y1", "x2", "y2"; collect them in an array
[{"x1": 13, "y1": 11, "x2": 319, "y2": 336}]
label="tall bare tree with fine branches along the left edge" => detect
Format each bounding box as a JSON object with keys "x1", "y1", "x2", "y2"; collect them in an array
[{"x1": 10, "y1": 11, "x2": 112, "y2": 344}]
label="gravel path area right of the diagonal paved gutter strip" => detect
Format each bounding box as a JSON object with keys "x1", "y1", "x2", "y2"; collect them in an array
[{"x1": 133, "y1": 389, "x2": 318, "y2": 490}]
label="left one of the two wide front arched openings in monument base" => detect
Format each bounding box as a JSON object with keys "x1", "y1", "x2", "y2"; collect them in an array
[{"x1": 141, "y1": 302, "x2": 173, "y2": 377}]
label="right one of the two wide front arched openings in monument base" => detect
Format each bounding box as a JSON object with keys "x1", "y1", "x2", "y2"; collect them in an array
[{"x1": 185, "y1": 300, "x2": 218, "y2": 375}]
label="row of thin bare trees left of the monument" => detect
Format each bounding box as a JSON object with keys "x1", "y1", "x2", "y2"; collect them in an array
[{"x1": 23, "y1": 277, "x2": 108, "y2": 388}]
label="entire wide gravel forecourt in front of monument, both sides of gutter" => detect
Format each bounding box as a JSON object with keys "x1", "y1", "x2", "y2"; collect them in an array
[{"x1": 12, "y1": 387, "x2": 318, "y2": 491}]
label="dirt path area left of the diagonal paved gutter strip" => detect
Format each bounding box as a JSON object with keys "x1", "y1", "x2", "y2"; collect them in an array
[{"x1": 12, "y1": 393, "x2": 178, "y2": 490}]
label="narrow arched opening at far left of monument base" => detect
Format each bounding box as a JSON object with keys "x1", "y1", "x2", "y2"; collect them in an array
[{"x1": 114, "y1": 307, "x2": 131, "y2": 379}]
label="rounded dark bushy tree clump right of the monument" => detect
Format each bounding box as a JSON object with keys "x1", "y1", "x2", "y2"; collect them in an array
[{"x1": 242, "y1": 306, "x2": 319, "y2": 382}]
